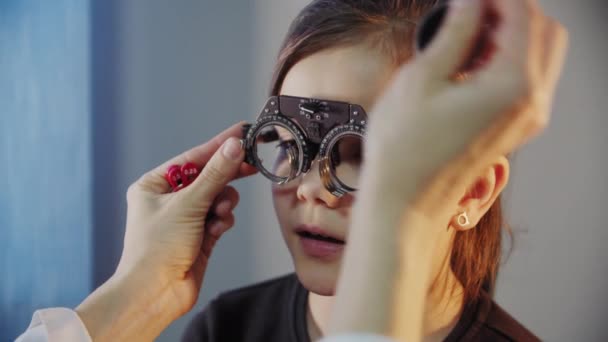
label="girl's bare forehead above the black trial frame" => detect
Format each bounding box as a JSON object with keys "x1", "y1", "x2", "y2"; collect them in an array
[{"x1": 281, "y1": 45, "x2": 395, "y2": 112}]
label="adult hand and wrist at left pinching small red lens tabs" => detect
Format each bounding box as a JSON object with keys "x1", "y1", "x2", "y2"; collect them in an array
[{"x1": 76, "y1": 123, "x2": 256, "y2": 340}]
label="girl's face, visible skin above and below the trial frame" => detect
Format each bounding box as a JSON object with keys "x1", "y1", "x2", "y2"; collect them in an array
[{"x1": 272, "y1": 45, "x2": 396, "y2": 295}]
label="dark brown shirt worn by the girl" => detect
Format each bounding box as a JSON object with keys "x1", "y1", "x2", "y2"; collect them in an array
[{"x1": 182, "y1": 274, "x2": 539, "y2": 342}]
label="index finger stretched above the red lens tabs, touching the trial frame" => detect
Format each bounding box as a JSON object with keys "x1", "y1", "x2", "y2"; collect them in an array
[{"x1": 137, "y1": 121, "x2": 250, "y2": 194}]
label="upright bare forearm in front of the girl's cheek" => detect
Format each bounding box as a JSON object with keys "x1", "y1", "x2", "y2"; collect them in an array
[{"x1": 331, "y1": 179, "x2": 434, "y2": 341}]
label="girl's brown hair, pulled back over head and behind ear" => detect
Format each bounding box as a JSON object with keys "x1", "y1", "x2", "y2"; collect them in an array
[{"x1": 270, "y1": 0, "x2": 503, "y2": 302}]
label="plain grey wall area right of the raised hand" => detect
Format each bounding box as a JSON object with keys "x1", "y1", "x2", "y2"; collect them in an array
[{"x1": 497, "y1": 0, "x2": 608, "y2": 341}]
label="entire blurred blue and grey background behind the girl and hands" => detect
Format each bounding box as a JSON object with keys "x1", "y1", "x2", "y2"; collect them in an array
[{"x1": 0, "y1": 0, "x2": 608, "y2": 341}]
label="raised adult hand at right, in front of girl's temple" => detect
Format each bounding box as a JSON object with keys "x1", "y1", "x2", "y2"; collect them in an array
[{"x1": 363, "y1": 0, "x2": 567, "y2": 217}]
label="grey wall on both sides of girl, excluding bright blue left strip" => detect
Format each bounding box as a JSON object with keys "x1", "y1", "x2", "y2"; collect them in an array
[{"x1": 3, "y1": 0, "x2": 608, "y2": 341}]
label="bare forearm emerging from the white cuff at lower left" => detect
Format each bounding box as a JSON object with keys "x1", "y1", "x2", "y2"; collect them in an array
[{"x1": 76, "y1": 274, "x2": 177, "y2": 341}]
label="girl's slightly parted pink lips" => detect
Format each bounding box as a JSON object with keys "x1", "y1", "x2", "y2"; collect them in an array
[{"x1": 295, "y1": 225, "x2": 346, "y2": 260}]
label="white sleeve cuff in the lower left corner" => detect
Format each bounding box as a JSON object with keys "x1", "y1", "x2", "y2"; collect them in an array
[{"x1": 15, "y1": 308, "x2": 92, "y2": 342}]
